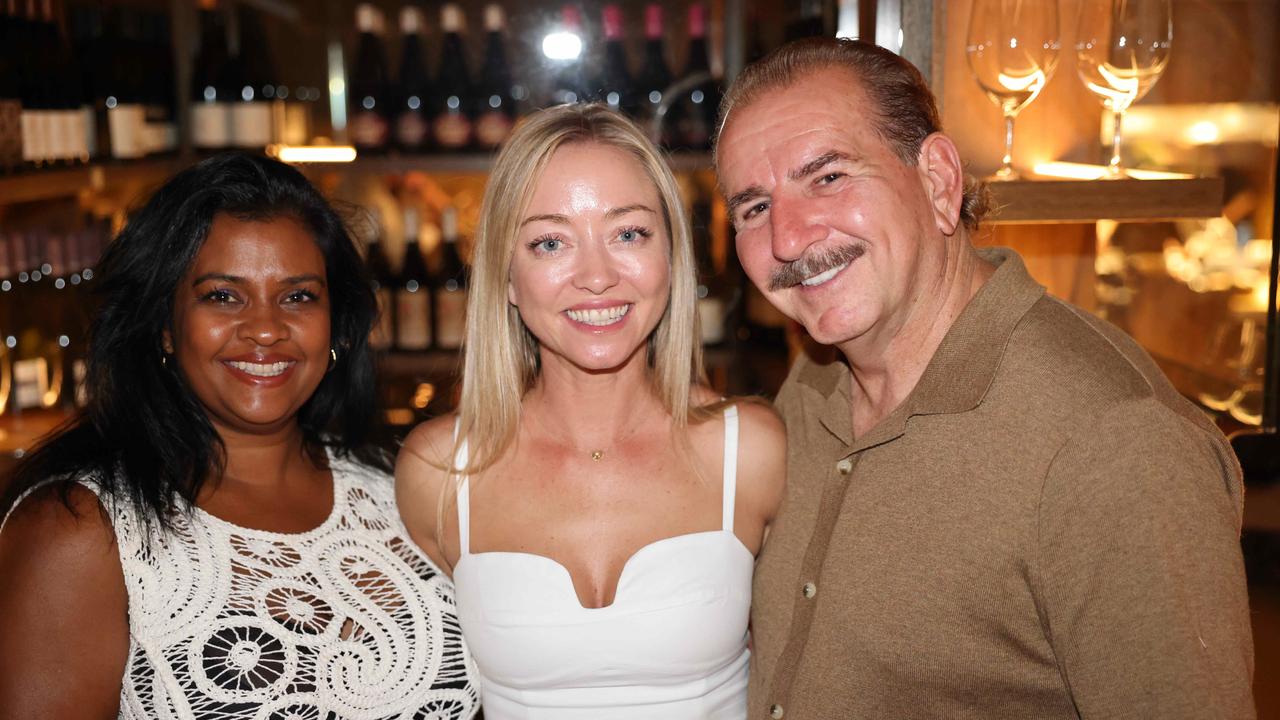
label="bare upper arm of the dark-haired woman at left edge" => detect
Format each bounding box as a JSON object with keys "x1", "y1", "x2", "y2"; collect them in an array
[{"x1": 0, "y1": 486, "x2": 129, "y2": 720}]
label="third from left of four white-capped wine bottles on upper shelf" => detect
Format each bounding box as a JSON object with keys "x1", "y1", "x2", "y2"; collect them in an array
[{"x1": 431, "y1": 3, "x2": 474, "y2": 152}]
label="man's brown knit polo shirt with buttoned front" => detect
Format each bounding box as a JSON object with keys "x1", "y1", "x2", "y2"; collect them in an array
[{"x1": 750, "y1": 243, "x2": 1254, "y2": 720}]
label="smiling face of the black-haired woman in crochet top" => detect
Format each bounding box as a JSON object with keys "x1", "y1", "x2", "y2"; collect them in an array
[{"x1": 164, "y1": 215, "x2": 329, "y2": 434}]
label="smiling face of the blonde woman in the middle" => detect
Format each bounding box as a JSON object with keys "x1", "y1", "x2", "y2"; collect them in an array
[{"x1": 508, "y1": 142, "x2": 671, "y2": 370}]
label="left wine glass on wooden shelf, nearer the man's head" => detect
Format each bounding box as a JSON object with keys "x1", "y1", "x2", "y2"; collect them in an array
[{"x1": 965, "y1": 0, "x2": 1059, "y2": 179}]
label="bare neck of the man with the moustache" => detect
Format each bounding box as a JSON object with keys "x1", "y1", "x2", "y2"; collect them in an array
[{"x1": 838, "y1": 238, "x2": 995, "y2": 437}]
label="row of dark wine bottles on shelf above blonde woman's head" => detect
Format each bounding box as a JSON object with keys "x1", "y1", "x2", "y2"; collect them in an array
[{"x1": 348, "y1": 3, "x2": 719, "y2": 152}]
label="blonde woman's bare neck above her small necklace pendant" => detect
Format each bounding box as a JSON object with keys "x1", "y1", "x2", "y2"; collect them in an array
[{"x1": 524, "y1": 346, "x2": 666, "y2": 450}]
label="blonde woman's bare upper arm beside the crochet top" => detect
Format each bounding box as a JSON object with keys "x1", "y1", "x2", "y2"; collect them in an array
[{"x1": 396, "y1": 415, "x2": 465, "y2": 574}]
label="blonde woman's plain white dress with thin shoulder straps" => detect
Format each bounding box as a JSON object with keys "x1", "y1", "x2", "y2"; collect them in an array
[{"x1": 453, "y1": 407, "x2": 755, "y2": 720}]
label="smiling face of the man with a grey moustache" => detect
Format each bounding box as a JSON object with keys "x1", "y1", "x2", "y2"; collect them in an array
[{"x1": 717, "y1": 69, "x2": 956, "y2": 345}]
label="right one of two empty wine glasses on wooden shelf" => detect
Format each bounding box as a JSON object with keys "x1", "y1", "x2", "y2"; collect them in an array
[{"x1": 1075, "y1": 0, "x2": 1174, "y2": 179}]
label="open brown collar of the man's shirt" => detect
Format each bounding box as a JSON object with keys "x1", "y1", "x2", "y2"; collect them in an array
[{"x1": 796, "y1": 247, "x2": 1044, "y2": 450}]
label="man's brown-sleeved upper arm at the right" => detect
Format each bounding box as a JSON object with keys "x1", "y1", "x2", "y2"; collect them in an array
[{"x1": 1034, "y1": 402, "x2": 1253, "y2": 717}]
